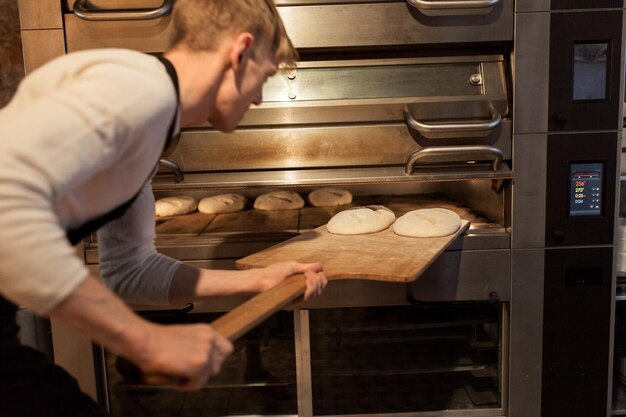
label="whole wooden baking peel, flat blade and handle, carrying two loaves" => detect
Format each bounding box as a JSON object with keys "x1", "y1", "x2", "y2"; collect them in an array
[{"x1": 129, "y1": 220, "x2": 469, "y2": 385}]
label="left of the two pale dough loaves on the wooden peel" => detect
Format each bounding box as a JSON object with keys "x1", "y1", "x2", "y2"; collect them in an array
[{"x1": 326, "y1": 206, "x2": 396, "y2": 235}]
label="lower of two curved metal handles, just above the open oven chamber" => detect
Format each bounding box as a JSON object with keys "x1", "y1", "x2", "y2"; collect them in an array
[{"x1": 404, "y1": 146, "x2": 504, "y2": 175}]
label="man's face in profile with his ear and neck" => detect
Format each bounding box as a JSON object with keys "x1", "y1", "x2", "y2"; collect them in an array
[{"x1": 208, "y1": 49, "x2": 277, "y2": 132}]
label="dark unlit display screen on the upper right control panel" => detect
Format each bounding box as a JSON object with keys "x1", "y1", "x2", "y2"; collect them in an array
[{"x1": 572, "y1": 43, "x2": 609, "y2": 101}]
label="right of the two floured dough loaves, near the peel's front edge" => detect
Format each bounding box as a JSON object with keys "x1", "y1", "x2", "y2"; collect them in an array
[{"x1": 393, "y1": 208, "x2": 461, "y2": 237}]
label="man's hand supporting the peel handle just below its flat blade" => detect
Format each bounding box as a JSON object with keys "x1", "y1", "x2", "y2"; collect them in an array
[{"x1": 249, "y1": 261, "x2": 328, "y2": 300}]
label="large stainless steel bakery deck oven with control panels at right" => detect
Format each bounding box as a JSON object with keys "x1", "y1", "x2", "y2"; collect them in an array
[{"x1": 20, "y1": 0, "x2": 623, "y2": 417}]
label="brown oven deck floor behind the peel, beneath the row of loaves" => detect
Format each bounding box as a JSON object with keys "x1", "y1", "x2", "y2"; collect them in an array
[{"x1": 84, "y1": 194, "x2": 511, "y2": 264}]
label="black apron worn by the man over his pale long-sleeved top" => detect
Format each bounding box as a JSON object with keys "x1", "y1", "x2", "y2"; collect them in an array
[{"x1": 0, "y1": 58, "x2": 179, "y2": 417}]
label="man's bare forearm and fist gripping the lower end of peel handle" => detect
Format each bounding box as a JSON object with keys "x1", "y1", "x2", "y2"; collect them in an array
[{"x1": 50, "y1": 276, "x2": 232, "y2": 390}]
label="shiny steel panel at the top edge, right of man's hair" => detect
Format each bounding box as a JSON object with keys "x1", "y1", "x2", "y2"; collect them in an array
[{"x1": 280, "y1": 0, "x2": 513, "y2": 48}]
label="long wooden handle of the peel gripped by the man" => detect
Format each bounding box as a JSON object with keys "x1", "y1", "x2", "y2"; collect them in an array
[{"x1": 118, "y1": 274, "x2": 306, "y2": 385}]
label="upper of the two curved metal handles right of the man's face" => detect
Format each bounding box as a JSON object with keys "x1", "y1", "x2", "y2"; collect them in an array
[{"x1": 404, "y1": 107, "x2": 502, "y2": 139}]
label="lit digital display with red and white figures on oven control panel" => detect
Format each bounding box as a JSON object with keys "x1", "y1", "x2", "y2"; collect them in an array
[{"x1": 569, "y1": 162, "x2": 604, "y2": 217}]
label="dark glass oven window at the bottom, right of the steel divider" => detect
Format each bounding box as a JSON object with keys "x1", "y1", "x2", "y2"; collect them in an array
[{"x1": 310, "y1": 303, "x2": 502, "y2": 415}]
